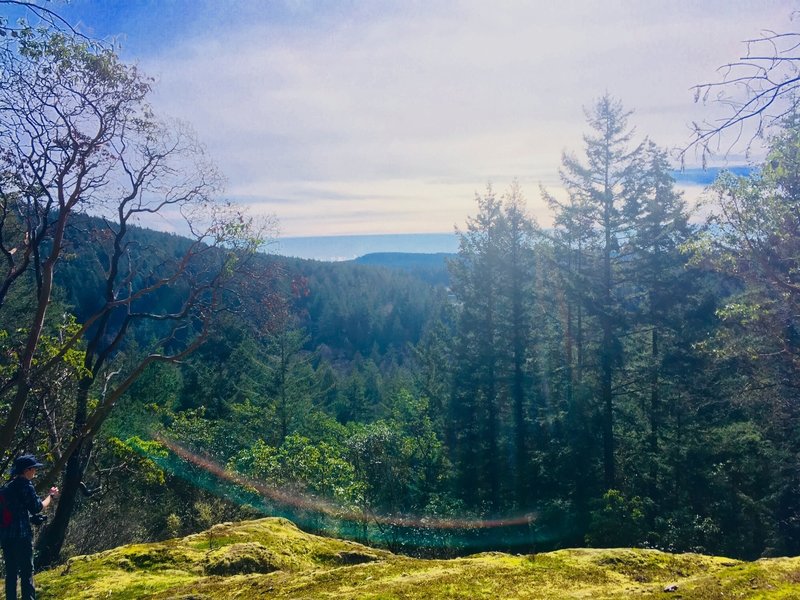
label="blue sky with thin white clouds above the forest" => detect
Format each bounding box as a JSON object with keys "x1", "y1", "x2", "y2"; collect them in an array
[{"x1": 7, "y1": 0, "x2": 798, "y2": 236}]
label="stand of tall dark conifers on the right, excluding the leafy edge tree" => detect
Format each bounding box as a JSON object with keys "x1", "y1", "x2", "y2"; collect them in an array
[{"x1": 446, "y1": 97, "x2": 736, "y2": 555}]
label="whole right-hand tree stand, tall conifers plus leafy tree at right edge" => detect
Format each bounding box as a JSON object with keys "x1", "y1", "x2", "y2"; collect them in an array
[{"x1": 443, "y1": 97, "x2": 800, "y2": 558}]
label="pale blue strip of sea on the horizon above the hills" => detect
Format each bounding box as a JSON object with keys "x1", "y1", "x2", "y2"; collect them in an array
[{"x1": 269, "y1": 233, "x2": 458, "y2": 262}]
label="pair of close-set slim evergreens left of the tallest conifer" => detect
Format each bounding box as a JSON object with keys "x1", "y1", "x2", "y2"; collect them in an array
[{"x1": 445, "y1": 185, "x2": 540, "y2": 510}]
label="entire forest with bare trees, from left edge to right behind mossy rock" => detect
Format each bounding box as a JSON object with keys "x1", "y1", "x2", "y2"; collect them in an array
[{"x1": 0, "y1": 9, "x2": 800, "y2": 564}]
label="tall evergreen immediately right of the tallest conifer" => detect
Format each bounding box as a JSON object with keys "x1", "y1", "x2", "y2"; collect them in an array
[{"x1": 622, "y1": 141, "x2": 697, "y2": 506}]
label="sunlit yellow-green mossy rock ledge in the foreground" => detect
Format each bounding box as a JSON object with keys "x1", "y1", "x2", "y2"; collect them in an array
[{"x1": 37, "y1": 518, "x2": 800, "y2": 600}]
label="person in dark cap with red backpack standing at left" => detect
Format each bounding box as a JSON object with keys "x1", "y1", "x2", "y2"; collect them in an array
[{"x1": 0, "y1": 454, "x2": 58, "y2": 600}]
